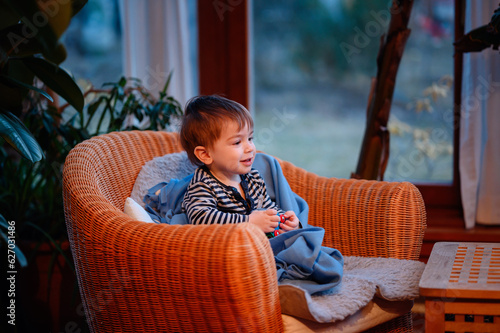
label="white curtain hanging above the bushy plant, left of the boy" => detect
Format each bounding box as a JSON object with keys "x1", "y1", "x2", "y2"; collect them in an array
[{"x1": 120, "y1": 0, "x2": 195, "y2": 106}]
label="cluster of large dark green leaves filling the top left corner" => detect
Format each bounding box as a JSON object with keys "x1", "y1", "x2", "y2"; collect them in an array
[{"x1": 0, "y1": 0, "x2": 87, "y2": 162}]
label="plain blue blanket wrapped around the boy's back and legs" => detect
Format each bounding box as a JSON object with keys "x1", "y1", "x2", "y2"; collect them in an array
[{"x1": 144, "y1": 153, "x2": 344, "y2": 294}]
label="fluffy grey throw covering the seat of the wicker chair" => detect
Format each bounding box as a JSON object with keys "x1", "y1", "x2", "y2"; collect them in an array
[{"x1": 279, "y1": 256, "x2": 425, "y2": 323}]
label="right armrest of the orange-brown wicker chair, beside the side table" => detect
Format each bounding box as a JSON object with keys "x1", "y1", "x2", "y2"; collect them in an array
[{"x1": 280, "y1": 161, "x2": 426, "y2": 260}]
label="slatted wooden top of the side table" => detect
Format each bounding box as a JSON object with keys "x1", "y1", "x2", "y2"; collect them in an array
[{"x1": 419, "y1": 242, "x2": 500, "y2": 301}]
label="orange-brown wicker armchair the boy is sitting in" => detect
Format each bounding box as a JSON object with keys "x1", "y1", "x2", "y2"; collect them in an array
[{"x1": 63, "y1": 131, "x2": 425, "y2": 332}]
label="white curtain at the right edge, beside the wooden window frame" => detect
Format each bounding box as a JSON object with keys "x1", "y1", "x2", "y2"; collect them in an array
[{"x1": 459, "y1": 0, "x2": 500, "y2": 229}]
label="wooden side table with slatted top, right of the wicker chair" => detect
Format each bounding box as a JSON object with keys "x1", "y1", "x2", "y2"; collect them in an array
[{"x1": 419, "y1": 242, "x2": 500, "y2": 333}]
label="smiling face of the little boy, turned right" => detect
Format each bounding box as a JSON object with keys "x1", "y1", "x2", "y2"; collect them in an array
[{"x1": 205, "y1": 121, "x2": 256, "y2": 185}]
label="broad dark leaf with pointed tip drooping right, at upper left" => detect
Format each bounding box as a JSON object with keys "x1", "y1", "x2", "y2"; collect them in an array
[{"x1": 19, "y1": 57, "x2": 85, "y2": 112}]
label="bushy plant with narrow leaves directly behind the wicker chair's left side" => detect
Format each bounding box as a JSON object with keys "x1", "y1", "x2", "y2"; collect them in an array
[{"x1": 0, "y1": 77, "x2": 182, "y2": 329}]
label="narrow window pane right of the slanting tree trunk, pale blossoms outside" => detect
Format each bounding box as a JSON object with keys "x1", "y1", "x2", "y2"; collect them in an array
[{"x1": 385, "y1": 0, "x2": 455, "y2": 183}]
